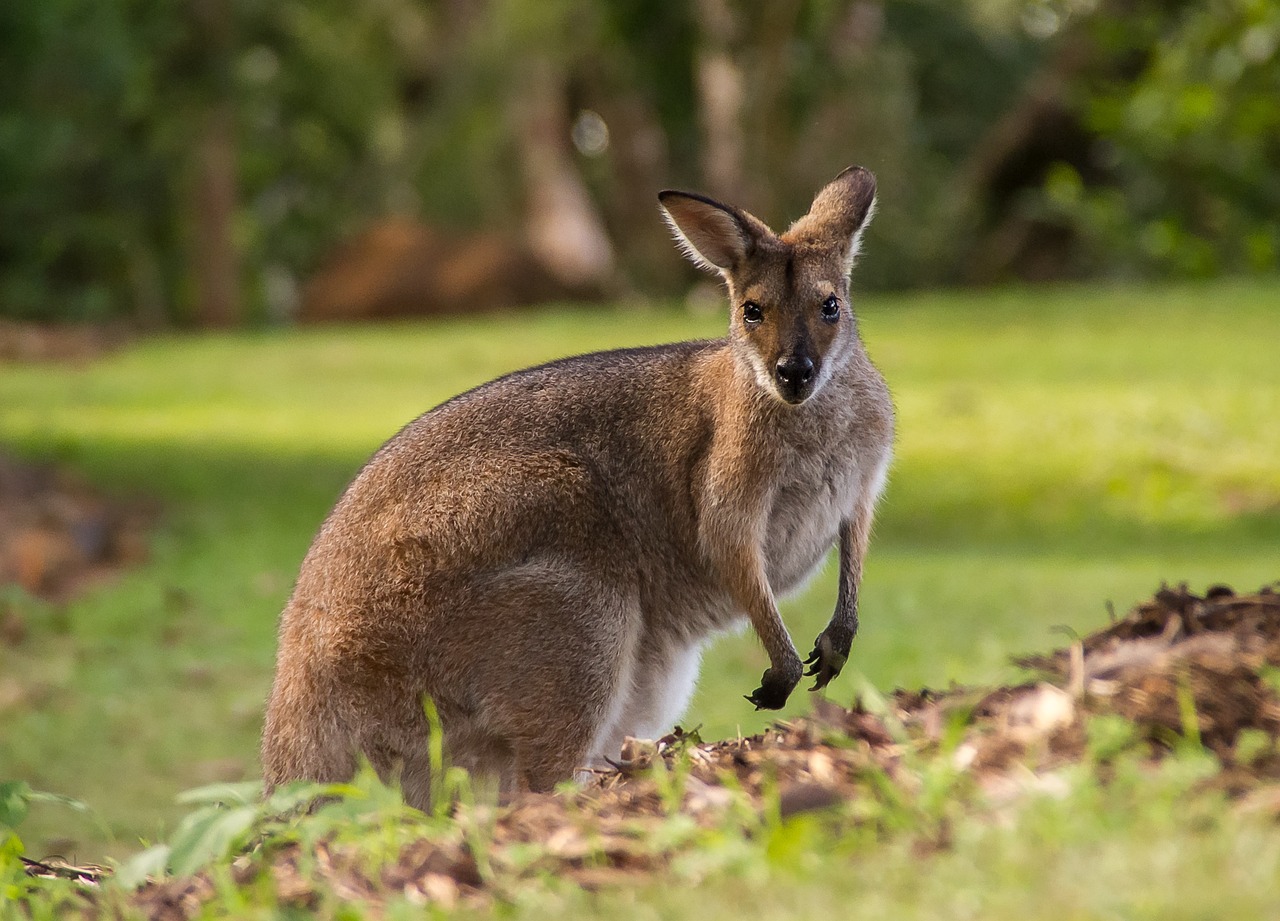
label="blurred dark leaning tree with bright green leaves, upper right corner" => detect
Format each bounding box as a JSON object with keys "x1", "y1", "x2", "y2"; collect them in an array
[{"x1": 969, "y1": 0, "x2": 1280, "y2": 281}]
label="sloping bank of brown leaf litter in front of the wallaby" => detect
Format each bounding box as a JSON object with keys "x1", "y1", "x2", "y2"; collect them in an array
[{"x1": 24, "y1": 585, "x2": 1280, "y2": 921}]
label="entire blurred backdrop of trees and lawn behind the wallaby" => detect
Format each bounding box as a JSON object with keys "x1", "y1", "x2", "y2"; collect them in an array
[{"x1": 0, "y1": 0, "x2": 1280, "y2": 860}]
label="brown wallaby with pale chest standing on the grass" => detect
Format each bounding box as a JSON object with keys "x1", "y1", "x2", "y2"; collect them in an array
[{"x1": 262, "y1": 168, "x2": 893, "y2": 807}]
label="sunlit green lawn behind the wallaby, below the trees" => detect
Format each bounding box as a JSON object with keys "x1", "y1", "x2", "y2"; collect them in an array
[{"x1": 0, "y1": 281, "x2": 1280, "y2": 869}]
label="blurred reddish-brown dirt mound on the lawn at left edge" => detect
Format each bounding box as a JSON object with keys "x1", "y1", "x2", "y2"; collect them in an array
[{"x1": 0, "y1": 454, "x2": 155, "y2": 601}]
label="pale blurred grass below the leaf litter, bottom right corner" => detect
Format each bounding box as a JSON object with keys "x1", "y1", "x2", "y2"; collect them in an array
[{"x1": 570, "y1": 765, "x2": 1280, "y2": 921}]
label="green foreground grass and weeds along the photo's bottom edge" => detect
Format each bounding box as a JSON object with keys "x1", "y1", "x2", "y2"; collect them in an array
[{"x1": 17, "y1": 718, "x2": 1280, "y2": 921}]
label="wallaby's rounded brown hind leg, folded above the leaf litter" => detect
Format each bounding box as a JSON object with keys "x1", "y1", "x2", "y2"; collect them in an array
[{"x1": 338, "y1": 559, "x2": 640, "y2": 810}]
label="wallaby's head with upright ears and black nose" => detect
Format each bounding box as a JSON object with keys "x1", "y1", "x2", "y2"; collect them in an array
[{"x1": 658, "y1": 166, "x2": 876, "y2": 405}]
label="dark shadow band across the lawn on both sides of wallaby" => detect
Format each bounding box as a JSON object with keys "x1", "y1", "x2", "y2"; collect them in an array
[{"x1": 15, "y1": 429, "x2": 1280, "y2": 562}]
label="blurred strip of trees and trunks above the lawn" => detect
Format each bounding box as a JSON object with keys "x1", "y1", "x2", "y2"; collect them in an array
[{"x1": 0, "y1": 0, "x2": 1280, "y2": 326}]
